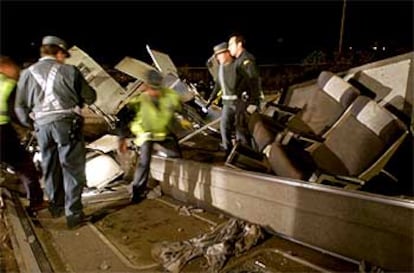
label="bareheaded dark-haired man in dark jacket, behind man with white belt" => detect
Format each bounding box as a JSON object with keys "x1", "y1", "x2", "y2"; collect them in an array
[{"x1": 228, "y1": 34, "x2": 263, "y2": 146}]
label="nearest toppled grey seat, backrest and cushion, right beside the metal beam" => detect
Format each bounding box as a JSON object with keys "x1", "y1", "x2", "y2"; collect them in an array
[{"x1": 268, "y1": 96, "x2": 408, "y2": 184}]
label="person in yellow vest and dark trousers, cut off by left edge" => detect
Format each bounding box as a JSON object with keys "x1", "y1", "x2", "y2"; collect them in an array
[{"x1": 0, "y1": 56, "x2": 45, "y2": 210}]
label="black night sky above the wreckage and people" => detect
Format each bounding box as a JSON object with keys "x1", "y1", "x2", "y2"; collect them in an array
[{"x1": 0, "y1": 0, "x2": 413, "y2": 66}]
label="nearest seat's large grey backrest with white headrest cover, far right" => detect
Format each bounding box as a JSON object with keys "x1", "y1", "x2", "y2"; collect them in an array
[{"x1": 307, "y1": 96, "x2": 408, "y2": 180}]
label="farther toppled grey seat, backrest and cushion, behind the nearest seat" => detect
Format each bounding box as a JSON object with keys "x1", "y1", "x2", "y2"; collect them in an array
[{"x1": 249, "y1": 71, "x2": 360, "y2": 151}]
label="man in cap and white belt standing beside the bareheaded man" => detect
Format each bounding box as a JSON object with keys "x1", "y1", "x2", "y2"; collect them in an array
[{"x1": 206, "y1": 42, "x2": 238, "y2": 158}]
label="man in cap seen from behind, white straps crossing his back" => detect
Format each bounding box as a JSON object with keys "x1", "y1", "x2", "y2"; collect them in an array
[{"x1": 15, "y1": 36, "x2": 96, "y2": 229}]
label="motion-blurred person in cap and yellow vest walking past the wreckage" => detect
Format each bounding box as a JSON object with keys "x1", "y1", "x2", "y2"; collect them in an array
[{"x1": 118, "y1": 70, "x2": 191, "y2": 203}]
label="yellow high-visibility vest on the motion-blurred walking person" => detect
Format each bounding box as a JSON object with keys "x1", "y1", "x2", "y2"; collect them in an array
[{"x1": 128, "y1": 88, "x2": 181, "y2": 146}]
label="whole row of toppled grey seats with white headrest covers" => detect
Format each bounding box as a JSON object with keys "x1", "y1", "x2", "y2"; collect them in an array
[{"x1": 244, "y1": 71, "x2": 408, "y2": 185}]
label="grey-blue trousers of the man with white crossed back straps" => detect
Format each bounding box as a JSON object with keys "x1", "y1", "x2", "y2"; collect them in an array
[{"x1": 35, "y1": 117, "x2": 86, "y2": 219}]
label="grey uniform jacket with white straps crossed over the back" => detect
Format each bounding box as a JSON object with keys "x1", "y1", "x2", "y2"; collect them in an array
[{"x1": 15, "y1": 57, "x2": 96, "y2": 127}]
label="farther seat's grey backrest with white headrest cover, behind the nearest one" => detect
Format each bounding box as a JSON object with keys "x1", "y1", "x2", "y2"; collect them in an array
[{"x1": 288, "y1": 71, "x2": 360, "y2": 136}]
